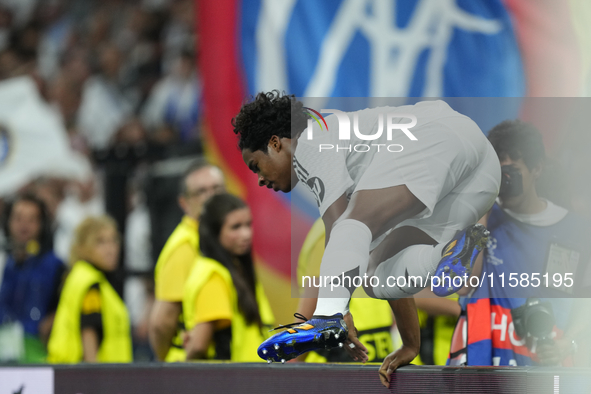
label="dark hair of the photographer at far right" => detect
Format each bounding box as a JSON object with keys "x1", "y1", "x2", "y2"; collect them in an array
[{"x1": 488, "y1": 119, "x2": 546, "y2": 171}]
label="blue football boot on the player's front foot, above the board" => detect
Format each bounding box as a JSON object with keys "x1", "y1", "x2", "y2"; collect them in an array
[{"x1": 257, "y1": 313, "x2": 348, "y2": 363}]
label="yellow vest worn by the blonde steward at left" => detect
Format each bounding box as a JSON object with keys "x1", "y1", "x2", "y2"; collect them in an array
[{"x1": 47, "y1": 261, "x2": 133, "y2": 363}]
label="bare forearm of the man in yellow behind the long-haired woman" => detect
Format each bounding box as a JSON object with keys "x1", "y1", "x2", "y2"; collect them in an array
[{"x1": 148, "y1": 300, "x2": 181, "y2": 361}]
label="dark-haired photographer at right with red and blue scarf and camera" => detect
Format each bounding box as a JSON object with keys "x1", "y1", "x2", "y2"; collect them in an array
[{"x1": 448, "y1": 120, "x2": 589, "y2": 366}]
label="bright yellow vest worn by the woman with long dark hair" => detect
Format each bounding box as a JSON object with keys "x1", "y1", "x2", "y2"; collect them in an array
[{"x1": 183, "y1": 256, "x2": 274, "y2": 362}]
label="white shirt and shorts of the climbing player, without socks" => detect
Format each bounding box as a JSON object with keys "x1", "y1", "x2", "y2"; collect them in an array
[{"x1": 293, "y1": 100, "x2": 501, "y2": 246}]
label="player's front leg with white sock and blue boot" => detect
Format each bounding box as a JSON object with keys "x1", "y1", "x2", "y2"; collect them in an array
[{"x1": 278, "y1": 185, "x2": 425, "y2": 361}]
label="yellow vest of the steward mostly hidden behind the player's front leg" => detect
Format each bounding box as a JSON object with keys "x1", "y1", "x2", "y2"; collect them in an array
[{"x1": 298, "y1": 219, "x2": 394, "y2": 363}]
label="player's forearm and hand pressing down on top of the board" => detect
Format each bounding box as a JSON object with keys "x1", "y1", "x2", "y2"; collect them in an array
[{"x1": 380, "y1": 297, "x2": 421, "y2": 387}]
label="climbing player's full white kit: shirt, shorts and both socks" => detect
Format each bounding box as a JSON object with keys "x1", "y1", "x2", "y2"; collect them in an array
[{"x1": 293, "y1": 100, "x2": 501, "y2": 302}]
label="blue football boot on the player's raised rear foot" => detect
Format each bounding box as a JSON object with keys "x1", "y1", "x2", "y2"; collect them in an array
[{"x1": 433, "y1": 223, "x2": 490, "y2": 297}]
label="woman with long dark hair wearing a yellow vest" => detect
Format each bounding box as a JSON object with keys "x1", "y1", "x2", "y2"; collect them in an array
[{"x1": 183, "y1": 194, "x2": 273, "y2": 362}]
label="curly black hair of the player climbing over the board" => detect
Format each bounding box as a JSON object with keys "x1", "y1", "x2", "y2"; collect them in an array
[{"x1": 232, "y1": 90, "x2": 309, "y2": 153}]
